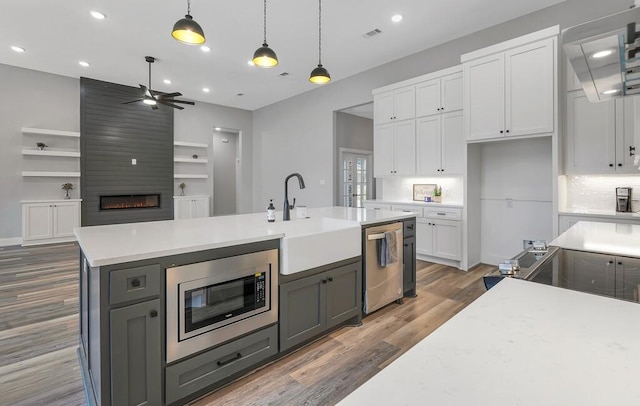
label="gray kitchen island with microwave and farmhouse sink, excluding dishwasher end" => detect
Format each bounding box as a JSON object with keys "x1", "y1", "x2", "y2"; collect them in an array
[{"x1": 75, "y1": 207, "x2": 415, "y2": 405}]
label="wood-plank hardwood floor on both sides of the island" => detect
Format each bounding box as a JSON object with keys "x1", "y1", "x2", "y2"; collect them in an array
[{"x1": 0, "y1": 243, "x2": 491, "y2": 406}]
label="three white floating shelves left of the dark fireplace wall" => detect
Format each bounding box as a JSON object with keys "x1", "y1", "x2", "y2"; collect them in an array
[{"x1": 22, "y1": 127, "x2": 80, "y2": 178}]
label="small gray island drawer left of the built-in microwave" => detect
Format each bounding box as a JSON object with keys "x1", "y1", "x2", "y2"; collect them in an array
[{"x1": 109, "y1": 264, "x2": 160, "y2": 305}]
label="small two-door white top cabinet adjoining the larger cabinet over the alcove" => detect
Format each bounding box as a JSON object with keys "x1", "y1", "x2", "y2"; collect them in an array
[{"x1": 416, "y1": 73, "x2": 462, "y2": 117}]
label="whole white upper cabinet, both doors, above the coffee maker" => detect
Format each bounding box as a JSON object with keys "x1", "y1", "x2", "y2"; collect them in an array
[{"x1": 565, "y1": 91, "x2": 640, "y2": 174}]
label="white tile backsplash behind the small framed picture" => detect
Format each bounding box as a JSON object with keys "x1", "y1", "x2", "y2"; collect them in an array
[{"x1": 377, "y1": 176, "x2": 464, "y2": 204}]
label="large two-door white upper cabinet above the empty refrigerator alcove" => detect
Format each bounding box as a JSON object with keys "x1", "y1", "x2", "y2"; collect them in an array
[{"x1": 463, "y1": 37, "x2": 556, "y2": 141}]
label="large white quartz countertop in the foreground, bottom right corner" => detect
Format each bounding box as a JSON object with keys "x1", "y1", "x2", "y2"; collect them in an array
[{"x1": 339, "y1": 278, "x2": 640, "y2": 406}]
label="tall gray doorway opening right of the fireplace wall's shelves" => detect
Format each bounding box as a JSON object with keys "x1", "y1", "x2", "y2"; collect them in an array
[{"x1": 211, "y1": 127, "x2": 240, "y2": 216}]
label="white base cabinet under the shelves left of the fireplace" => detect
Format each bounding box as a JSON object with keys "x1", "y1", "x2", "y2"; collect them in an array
[{"x1": 22, "y1": 199, "x2": 80, "y2": 245}]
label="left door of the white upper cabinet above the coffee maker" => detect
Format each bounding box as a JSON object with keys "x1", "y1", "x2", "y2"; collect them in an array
[{"x1": 565, "y1": 92, "x2": 616, "y2": 174}]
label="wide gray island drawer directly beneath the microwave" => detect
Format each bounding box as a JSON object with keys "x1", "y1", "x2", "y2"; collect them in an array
[{"x1": 165, "y1": 324, "x2": 278, "y2": 404}]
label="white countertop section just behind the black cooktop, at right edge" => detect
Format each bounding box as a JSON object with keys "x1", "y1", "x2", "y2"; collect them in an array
[{"x1": 549, "y1": 221, "x2": 640, "y2": 258}]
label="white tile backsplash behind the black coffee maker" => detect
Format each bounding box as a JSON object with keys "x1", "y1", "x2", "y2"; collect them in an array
[{"x1": 561, "y1": 175, "x2": 640, "y2": 211}]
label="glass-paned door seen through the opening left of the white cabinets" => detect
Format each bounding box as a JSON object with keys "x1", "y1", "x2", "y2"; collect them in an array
[{"x1": 340, "y1": 148, "x2": 373, "y2": 207}]
